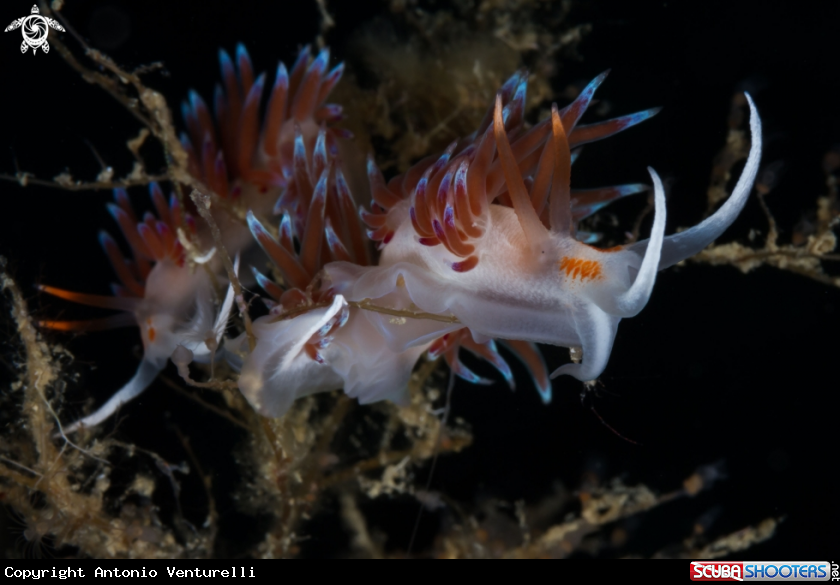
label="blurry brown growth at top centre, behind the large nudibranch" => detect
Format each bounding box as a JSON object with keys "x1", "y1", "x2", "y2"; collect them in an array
[{"x1": 335, "y1": 0, "x2": 589, "y2": 172}]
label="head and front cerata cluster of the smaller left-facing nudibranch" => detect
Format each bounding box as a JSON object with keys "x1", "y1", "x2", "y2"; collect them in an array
[{"x1": 39, "y1": 184, "x2": 233, "y2": 432}]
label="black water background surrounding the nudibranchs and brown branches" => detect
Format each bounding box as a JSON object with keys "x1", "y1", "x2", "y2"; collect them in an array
[{"x1": 0, "y1": 0, "x2": 840, "y2": 560}]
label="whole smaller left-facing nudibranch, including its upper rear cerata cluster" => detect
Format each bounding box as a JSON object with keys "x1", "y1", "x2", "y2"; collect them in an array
[{"x1": 40, "y1": 44, "x2": 348, "y2": 432}]
